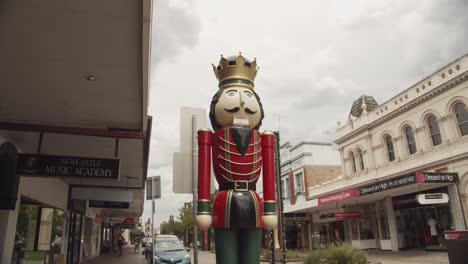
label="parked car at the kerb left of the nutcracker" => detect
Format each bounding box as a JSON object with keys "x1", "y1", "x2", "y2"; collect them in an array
[{"x1": 149, "y1": 235, "x2": 191, "y2": 264}]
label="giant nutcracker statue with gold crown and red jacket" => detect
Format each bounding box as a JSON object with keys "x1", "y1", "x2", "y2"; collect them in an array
[{"x1": 196, "y1": 54, "x2": 277, "y2": 264}]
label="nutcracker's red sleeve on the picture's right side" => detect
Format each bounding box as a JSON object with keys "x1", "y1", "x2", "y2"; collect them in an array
[{"x1": 262, "y1": 132, "x2": 275, "y2": 207}]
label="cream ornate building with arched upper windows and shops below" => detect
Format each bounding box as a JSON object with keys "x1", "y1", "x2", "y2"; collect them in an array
[{"x1": 300, "y1": 55, "x2": 468, "y2": 251}]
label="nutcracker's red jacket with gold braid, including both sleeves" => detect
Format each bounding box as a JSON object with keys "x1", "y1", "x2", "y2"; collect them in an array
[{"x1": 198, "y1": 128, "x2": 276, "y2": 228}]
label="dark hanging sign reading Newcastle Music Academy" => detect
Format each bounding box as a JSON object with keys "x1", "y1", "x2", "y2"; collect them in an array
[{"x1": 17, "y1": 154, "x2": 120, "y2": 180}]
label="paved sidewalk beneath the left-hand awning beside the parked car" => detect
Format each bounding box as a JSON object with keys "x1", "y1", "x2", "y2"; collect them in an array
[{"x1": 85, "y1": 245, "x2": 148, "y2": 264}]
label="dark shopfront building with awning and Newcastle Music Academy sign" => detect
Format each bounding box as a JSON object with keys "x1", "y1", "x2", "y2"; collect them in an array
[{"x1": 0, "y1": 0, "x2": 152, "y2": 264}]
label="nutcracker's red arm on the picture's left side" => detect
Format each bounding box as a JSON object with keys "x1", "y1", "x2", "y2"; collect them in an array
[{"x1": 197, "y1": 129, "x2": 213, "y2": 217}]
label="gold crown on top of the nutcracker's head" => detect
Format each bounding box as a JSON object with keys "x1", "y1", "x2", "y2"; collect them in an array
[{"x1": 213, "y1": 52, "x2": 258, "y2": 89}]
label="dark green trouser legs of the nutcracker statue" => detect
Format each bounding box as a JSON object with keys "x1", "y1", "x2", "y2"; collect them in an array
[{"x1": 215, "y1": 228, "x2": 262, "y2": 264}]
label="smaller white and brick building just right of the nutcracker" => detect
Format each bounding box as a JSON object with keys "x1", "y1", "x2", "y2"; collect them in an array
[{"x1": 280, "y1": 142, "x2": 341, "y2": 249}]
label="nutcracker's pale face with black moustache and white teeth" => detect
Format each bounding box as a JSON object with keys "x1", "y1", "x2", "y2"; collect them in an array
[{"x1": 215, "y1": 87, "x2": 261, "y2": 128}]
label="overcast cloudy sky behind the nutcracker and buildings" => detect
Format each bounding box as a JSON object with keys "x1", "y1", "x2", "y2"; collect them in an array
[{"x1": 143, "y1": 0, "x2": 468, "y2": 225}]
